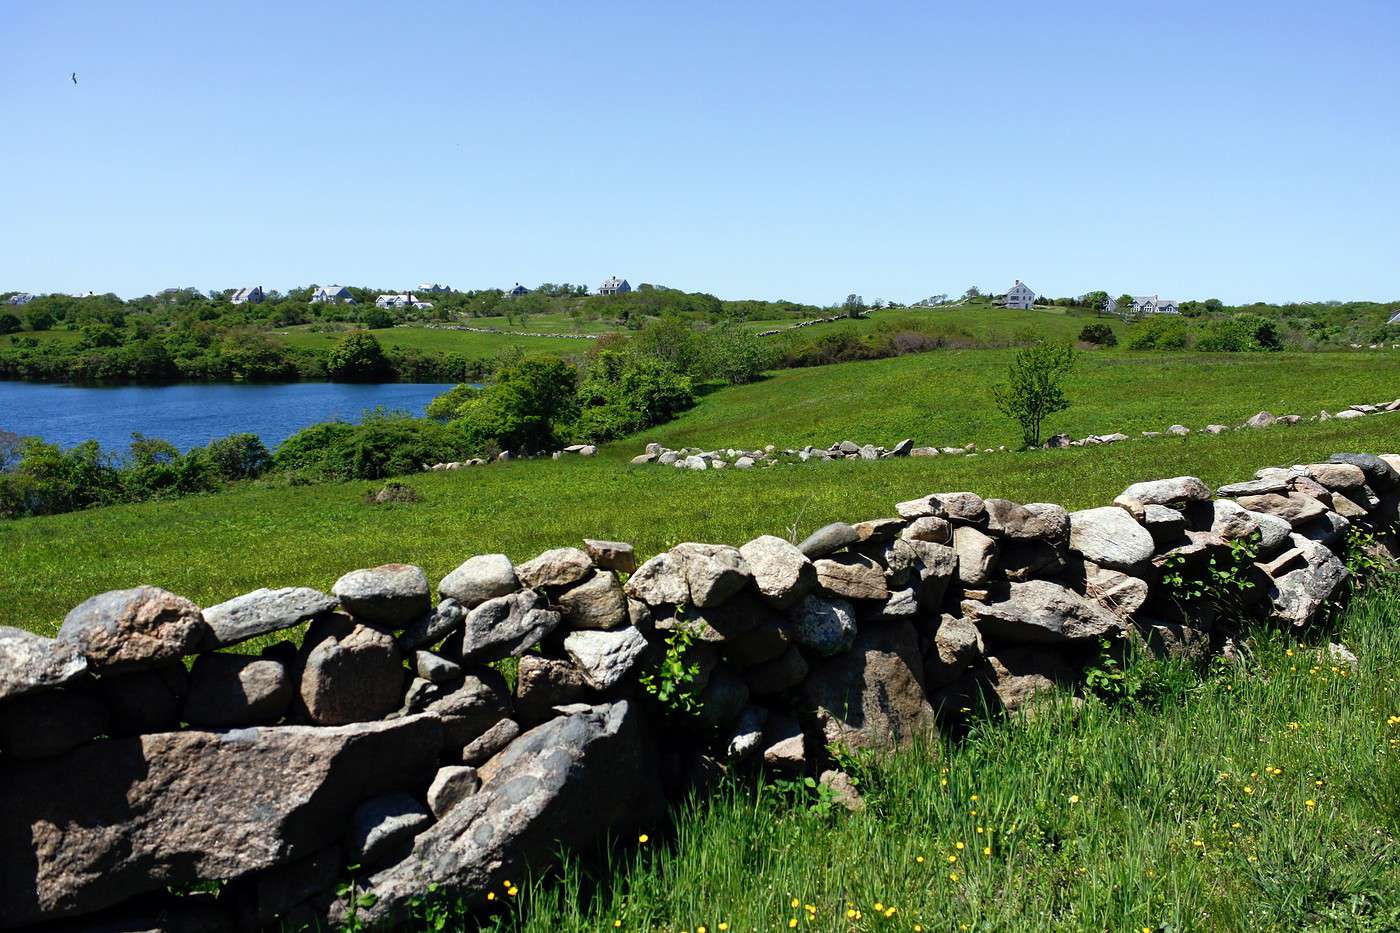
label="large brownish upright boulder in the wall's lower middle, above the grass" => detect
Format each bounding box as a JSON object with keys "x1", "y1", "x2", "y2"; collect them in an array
[{"x1": 801, "y1": 622, "x2": 935, "y2": 749}]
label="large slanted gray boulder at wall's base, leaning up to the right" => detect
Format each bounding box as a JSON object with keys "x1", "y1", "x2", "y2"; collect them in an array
[{"x1": 340, "y1": 702, "x2": 664, "y2": 927}]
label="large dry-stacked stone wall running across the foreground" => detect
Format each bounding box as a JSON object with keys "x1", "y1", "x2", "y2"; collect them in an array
[{"x1": 0, "y1": 454, "x2": 1400, "y2": 930}]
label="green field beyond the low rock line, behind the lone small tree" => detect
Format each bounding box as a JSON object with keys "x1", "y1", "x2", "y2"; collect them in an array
[{"x1": 638, "y1": 348, "x2": 1400, "y2": 452}]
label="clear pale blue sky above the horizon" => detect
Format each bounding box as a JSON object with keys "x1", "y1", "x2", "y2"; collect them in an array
[{"x1": 0, "y1": 0, "x2": 1400, "y2": 304}]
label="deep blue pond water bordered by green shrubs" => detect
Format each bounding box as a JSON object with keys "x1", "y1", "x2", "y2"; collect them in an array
[{"x1": 0, "y1": 381, "x2": 451, "y2": 451}]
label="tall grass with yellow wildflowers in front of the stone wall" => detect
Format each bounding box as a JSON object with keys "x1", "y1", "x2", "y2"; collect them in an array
[{"x1": 454, "y1": 583, "x2": 1400, "y2": 933}]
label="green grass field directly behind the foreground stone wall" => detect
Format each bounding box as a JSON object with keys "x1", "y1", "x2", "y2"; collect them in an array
[{"x1": 0, "y1": 415, "x2": 1400, "y2": 633}]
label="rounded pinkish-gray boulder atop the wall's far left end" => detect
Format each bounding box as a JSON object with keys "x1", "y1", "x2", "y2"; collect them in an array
[{"x1": 59, "y1": 587, "x2": 209, "y2": 675}]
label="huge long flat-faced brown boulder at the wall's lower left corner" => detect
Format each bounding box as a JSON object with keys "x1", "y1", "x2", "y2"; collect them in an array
[{"x1": 0, "y1": 716, "x2": 442, "y2": 927}]
